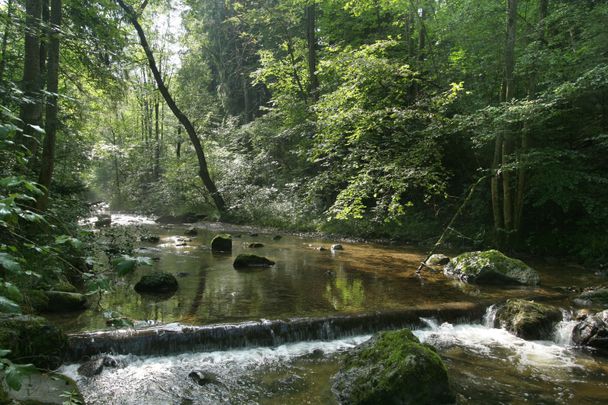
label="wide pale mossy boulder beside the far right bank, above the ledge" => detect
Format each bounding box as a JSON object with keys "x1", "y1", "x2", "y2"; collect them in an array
[{"x1": 443, "y1": 250, "x2": 540, "y2": 285}]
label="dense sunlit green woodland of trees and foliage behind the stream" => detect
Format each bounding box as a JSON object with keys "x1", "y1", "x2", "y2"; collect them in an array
[{"x1": 0, "y1": 0, "x2": 608, "y2": 296}]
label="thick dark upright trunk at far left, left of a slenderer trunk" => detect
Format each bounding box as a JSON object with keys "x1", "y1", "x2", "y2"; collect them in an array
[{"x1": 16, "y1": 0, "x2": 42, "y2": 156}]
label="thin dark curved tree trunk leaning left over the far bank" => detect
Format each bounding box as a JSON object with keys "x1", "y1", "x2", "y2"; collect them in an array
[{"x1": 116, "y1": 0, "x2": 226, "y2": 214}]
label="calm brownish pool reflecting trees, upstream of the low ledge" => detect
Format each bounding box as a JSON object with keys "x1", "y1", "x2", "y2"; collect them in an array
[{"x1": 55, "y1": 215, "x2": 604, "y2": 331}]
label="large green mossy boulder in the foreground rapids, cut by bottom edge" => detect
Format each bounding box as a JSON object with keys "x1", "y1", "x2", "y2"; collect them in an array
[{"x1": 332, "y1": 329, "x2": 455, "y2": 405}]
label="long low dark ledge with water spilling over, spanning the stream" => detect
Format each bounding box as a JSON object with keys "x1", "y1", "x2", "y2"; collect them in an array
[{"x1": 67, "y1": 303, "x2": 484, "y2": 361}]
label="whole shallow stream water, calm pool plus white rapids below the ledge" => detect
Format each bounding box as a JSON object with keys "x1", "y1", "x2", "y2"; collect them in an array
[{"x1": 54, "y1": 215, "x2": 608, "y2": 404}]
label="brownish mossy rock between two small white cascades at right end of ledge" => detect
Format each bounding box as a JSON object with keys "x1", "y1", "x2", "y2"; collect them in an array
[{"x1": 496, "y1": 299, "x2": 563, "y2": 340}]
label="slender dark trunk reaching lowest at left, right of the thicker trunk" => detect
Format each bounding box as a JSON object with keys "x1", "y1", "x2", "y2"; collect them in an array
[{"x1": 36, "y1": 0, "x2": 62, "y2": 211}]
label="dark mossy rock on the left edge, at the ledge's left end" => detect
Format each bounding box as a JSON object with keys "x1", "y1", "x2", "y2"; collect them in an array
[{"x1": 0, "y1": 314, "x2": 67, "y2": 369}]
